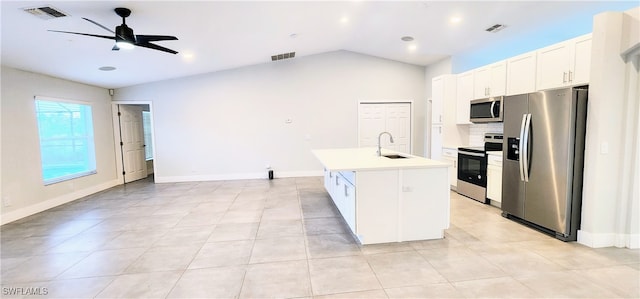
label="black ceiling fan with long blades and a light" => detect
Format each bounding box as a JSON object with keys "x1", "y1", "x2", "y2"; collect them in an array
[{"x1": 49, "y1": 7, "x2": 178, "y2": 54}]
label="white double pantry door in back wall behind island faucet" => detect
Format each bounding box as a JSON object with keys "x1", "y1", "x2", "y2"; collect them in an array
[{"x1": 358, "y1": 102, "x2": 411, "y2": 154}]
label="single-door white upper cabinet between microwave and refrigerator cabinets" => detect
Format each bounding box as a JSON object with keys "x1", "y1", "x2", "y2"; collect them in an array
[{"x1": 506, "y1": 51, "x2": 536, "y2": 95}]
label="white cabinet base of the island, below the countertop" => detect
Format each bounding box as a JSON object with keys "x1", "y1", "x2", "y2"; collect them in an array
[{"x1": 324, "y1": 167, "x2": 449, "y2": 245}]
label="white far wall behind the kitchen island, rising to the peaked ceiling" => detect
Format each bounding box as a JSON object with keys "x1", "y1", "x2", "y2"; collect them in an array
[{"x1": 114, "y1": 51, "x2": 426, "y2": 182}]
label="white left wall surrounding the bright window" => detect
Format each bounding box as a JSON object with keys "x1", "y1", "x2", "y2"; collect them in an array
[{"x1": 1, "y1": 67, "x2": 117, "y2": 224}]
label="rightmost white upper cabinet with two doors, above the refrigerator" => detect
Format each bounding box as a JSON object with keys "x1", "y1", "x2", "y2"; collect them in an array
[{"x1": 536, "y1": 34, "x2": 591, "y2": 90}]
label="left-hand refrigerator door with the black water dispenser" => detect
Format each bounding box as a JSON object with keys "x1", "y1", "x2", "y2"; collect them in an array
[{"x1": 502, "y1": 94, "x2": 528, "y2": 218}]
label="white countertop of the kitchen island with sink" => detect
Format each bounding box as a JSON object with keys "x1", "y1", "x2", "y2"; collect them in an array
[{"x1": 312, "y1": 147, "x2": 449, "y2": 171}]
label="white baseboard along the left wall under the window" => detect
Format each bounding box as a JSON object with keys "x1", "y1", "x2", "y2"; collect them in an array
[{"x1": 0, "y1": 180, "x2": 120, "y2": 225}]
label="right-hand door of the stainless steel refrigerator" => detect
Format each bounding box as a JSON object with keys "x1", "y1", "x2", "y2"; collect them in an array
[{"x1": 524, "y1": 88, "x2": 575, "y2": 234}]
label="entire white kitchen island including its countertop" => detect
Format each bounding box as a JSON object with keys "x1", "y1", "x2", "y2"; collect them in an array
[{"x1": 313, "y1": 147, "x2": 450, "y2": 244}]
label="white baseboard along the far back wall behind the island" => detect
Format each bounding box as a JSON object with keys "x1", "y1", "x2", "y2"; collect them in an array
[{"x1": 154, "y1": 170, "x2": 323, "y2": 183}]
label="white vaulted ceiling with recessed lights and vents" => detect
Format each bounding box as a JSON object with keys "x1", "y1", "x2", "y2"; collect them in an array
[{"x1": 1, "y1": 0, "x2": 638, "y2": 88}]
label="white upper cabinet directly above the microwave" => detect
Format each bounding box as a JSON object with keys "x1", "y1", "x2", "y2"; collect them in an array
[{"x1": 473, "y1": 60, "x2": 507, "y2": 99}]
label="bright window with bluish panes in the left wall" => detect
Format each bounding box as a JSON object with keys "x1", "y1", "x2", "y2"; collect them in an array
[{"x1": 35, "y1": 97, "x2": 96, "y2": 185}]
